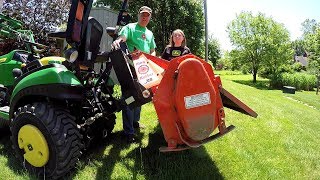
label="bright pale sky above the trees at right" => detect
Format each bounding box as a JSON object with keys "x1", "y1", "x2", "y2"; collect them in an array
[{"x1": 207, "y1": 0, "x2": 320, "y2": 50}]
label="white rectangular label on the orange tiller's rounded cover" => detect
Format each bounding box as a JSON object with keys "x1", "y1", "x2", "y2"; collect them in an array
[{"x1": 184, "y1": 92, "x2": 211, "y2": 109}]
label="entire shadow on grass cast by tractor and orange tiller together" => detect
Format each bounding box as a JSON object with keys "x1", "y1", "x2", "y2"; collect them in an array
[{"x1": 0, "y1": 126, "x2": 224, "y2": 180}]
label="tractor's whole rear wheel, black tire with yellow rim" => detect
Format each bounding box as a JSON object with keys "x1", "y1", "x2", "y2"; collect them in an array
[{"x1": 10, "y1": 103, "x2": 83, "y2": 179}]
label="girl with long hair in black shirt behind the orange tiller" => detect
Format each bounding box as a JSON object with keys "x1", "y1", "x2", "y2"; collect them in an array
[{"x1": 161, "y1": 29, "x2": 191, "y2": 61}]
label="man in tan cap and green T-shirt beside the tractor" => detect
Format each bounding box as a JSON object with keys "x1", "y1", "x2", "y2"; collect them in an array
[{"x1": 112, "y1": 6, "x2": 156, "y2": 143}]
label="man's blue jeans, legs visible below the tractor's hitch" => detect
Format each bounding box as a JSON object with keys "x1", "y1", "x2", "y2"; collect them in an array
[{"x1": 122, "y1": 106, "x2": 141, "y2": 135}]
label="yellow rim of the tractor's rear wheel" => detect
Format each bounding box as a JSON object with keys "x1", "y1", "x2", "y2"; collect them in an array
[{"x1": 18, "y1": 124, "x2": 49, "y2": 167}]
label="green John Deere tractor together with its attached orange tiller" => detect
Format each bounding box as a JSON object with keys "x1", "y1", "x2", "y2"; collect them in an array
[{"x1": 0, "y1": 0, "x2": 257, "y2": 179}]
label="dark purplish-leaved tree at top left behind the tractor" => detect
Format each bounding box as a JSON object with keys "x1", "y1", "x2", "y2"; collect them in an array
[{"x1": 2, "y1": 0, "x2": 70, "y2": 43}]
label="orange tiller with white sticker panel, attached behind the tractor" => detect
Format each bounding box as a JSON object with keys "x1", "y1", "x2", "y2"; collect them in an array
[{"x1": 132, "y1": 53, "x2": 257, "y2": 152}]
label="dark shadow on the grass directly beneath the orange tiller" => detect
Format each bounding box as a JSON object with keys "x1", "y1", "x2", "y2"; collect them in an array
[{"x1": 142, "y1": 125, "x2": 224, "y2": 179}]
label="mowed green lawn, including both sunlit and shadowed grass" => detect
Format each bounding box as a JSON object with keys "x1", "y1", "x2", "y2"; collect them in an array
[{"x1": 0, "y1": 72, "x2": 320, "y2": 180}]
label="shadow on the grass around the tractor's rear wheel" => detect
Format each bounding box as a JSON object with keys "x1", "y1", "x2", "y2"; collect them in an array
[{"x1": 0, "y1": 128, "x2": 129, "y2": 180}]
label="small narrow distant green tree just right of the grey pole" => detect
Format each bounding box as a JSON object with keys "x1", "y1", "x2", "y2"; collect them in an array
[{"x1": 208, "y1": 35, "x2": 221, "y2": 67}]
